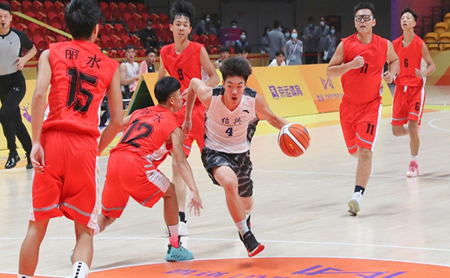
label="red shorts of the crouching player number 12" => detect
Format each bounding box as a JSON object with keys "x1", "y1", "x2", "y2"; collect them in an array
[{"x1": 102, "y1": 152, "x2": 170, "y2": 218}]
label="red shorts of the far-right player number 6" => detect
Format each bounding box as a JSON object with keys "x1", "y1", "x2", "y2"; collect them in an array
[{"x1": 391, "y1": 85, "x2": 425, "y2": 125}]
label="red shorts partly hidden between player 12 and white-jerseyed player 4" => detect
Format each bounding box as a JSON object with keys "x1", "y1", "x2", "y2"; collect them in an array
[{"x1": 175, "y1": 100, "x2": 206, "y2": 156}]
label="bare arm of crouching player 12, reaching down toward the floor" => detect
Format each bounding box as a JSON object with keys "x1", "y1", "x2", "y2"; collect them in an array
[{"x1": 169, "y1": 128, "x2": 203, "y2": 215}]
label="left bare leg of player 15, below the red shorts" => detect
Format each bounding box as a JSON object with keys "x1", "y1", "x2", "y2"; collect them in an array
[{"x1": 19, "y1": 219, "x2": 49, "y2": 277}]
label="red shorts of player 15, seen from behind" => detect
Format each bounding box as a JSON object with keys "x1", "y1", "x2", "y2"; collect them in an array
[{"x1": 30, "y1": 130, "x2": 98, "y2": 229}]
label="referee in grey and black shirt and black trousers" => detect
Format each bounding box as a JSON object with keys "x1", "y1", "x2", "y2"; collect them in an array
[{"x1": 0, "y1": 3, "x2": 37, "y2": 169}]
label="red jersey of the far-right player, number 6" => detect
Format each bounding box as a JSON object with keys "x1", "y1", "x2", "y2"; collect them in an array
[{"x1": 392, "y1": 35, "x2": 424, "y2": 87}]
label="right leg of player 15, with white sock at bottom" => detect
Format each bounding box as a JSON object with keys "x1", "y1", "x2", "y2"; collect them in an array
[{"x1": 72, "y1": 220, "x2": 94, "y2": 278}]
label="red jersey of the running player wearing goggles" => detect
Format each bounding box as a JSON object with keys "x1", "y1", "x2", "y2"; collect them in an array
[{"x1": 341, "y1": 34, "x2": 387, "y2": 104}]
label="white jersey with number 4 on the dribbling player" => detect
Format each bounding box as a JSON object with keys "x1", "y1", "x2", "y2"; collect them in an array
[{"x1": 205, "y1": 86, "x2": 259, "y2": 154}]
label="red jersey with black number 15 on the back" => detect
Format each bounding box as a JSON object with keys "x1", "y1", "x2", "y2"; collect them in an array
[{"x1": 42, "y1": 40, "x2": 119, "y2": 138}]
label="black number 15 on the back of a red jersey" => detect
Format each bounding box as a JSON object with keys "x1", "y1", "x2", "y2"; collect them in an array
[{"x1": 67, "y1": 68, "x2": 98, "y2": 114}]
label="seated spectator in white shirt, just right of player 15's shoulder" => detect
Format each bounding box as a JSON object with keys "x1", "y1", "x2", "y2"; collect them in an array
[{"x1": 119, "y1": 45, "x2": 141, "y2": 99}]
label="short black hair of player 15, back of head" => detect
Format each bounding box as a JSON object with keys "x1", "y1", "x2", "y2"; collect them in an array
[{"x1": 64, "y1": 0, "x2": 101, "y2": 39}]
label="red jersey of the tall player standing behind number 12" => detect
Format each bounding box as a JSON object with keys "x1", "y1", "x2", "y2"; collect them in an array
[{"x1": 161, "y1": 41, "x2": 203, "y2": 92}]
